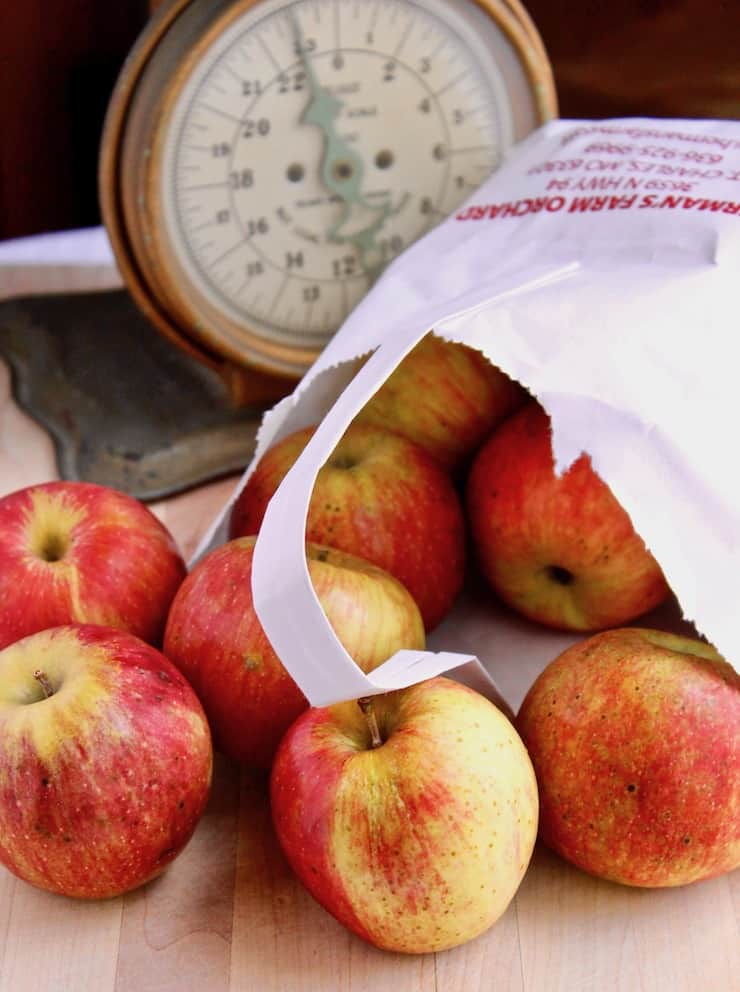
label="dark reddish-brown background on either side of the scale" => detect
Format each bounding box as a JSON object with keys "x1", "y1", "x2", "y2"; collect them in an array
[{"x1": 0, "y1": 0, "x2": 740, "y2": 239}]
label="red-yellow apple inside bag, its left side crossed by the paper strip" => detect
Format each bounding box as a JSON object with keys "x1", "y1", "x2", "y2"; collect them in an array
[{"x1": 229, "y1": 424, "x2": 466, "y2": 631}]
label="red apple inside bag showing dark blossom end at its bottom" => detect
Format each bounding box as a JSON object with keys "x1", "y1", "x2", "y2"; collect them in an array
[{"x1": 466, "y1": 403, "x2": 669, "y2": 631}]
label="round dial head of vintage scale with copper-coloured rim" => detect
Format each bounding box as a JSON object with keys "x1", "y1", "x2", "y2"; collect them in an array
[{"x1": 0, "y1": 0, "x2": 556, "y2": 498}]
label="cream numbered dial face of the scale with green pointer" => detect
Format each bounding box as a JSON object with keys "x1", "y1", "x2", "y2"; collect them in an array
[{"x1": 139, "y1": 0, "x2": 538, "y2": 366}]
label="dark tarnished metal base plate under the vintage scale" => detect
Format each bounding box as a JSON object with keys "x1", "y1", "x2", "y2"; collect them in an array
[{"x1": 0, "y1": 291, "x2": 264, "y2": 500}]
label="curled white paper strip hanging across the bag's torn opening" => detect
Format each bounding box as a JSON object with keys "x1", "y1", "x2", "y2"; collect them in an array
[{"x1": 252, "y1": 265, "x2": 576, "y2": 706}]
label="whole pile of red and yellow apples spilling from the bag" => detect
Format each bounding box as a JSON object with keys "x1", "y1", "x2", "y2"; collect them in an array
[{"x1": 0, "y1": 335, "x2": 740, "y2": 952}]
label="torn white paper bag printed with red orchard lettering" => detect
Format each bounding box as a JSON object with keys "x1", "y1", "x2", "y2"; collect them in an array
[{"x1": 196, "y1": 119, "x2": 740, "y2": 705}]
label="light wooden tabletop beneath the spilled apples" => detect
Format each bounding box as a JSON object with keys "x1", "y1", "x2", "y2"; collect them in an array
[{"x1": 0, "y1": 352, "x2": 740, "y2": 992}]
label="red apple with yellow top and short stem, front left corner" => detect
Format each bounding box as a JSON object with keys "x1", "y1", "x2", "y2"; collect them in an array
[{"x1": 0, "y1": 624, "x2": 212, "y2": 899}]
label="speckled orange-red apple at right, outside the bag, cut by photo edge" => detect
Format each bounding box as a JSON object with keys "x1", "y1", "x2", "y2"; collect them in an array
[{"x1": 517, "y1": 628, "x2": 740, "y2": 887}]
